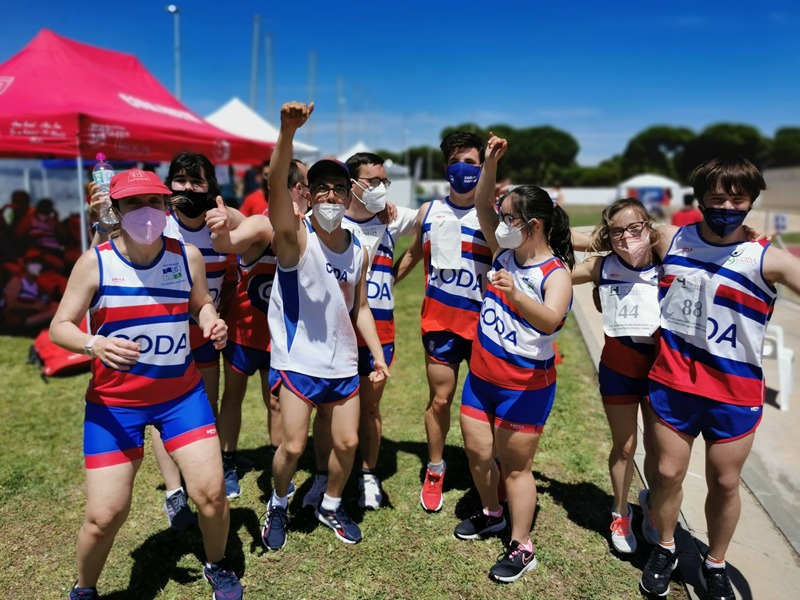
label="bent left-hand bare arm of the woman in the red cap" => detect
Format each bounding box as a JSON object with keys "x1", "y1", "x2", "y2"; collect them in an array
[{"x1": 50, "y1": 250, "x2": 139, "y2": 371}]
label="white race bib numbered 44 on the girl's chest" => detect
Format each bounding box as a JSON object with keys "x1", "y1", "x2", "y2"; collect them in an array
[{"x1": 600, "y1": 283, "x2": 660, "y2": 337}]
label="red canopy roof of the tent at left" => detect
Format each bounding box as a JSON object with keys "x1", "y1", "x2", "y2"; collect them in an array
[{"x1": 0, "y1": 29, "x2": 274, "y2": 164}]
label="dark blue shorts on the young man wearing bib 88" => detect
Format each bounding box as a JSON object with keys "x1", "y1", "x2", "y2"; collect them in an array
[{"x1": 650, "y1": 381, "x2": 764, "y2": 442}]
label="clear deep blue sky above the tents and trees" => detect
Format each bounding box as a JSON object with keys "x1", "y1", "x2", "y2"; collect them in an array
[{"x1": 0, "y1": 0, "x2": 800, "y2": 165}]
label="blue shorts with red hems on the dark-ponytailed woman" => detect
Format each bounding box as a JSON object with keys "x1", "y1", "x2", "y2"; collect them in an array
[{"x1": 461, "y1": 373, "x2": 556, "y2": 433}]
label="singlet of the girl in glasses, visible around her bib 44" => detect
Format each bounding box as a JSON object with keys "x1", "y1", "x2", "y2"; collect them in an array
[{"x1": 599, "y1": 252, "x2": 662, "y2": 379}]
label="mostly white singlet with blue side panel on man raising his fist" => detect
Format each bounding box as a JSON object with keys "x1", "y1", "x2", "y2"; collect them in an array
[{"x1": 268, "y1": 221, "x2": 364, "y2": 379}]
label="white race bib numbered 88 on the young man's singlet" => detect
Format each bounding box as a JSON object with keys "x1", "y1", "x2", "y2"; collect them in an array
[{"x1": 661, "y1": 277, "x2": 716, "y2": 339}]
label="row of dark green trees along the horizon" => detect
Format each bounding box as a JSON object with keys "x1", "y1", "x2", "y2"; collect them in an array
[{"x1": 378, "y1": 123, "x2": 800, "y2": 187}]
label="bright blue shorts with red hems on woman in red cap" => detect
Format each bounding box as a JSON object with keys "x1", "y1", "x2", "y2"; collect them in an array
[{"x1": 83, "y1": 383, "x2": 217, "y2": 469}]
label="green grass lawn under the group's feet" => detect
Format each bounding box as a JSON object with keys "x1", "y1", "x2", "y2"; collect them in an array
[{"x1": 0, "y1": 237, "x2": 687, "y2": 600}]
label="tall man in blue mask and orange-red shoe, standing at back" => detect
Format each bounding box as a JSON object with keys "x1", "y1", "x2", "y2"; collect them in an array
[{"x1": 395, "y1": 131, "x2": 492, "y2": 512}]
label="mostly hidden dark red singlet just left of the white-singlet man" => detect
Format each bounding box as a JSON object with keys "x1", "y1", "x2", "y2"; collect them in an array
[{"x1": 225, "y1": 246, "x2": 278, "y2": 350}]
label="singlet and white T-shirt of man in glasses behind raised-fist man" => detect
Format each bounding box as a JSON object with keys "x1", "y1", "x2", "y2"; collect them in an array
[{"x1": 342, "y1": 206, "x2": 417, "y2": 346}]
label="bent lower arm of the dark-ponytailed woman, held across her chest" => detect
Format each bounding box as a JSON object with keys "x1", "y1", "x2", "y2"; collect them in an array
[{"x1": 492, "y1": 269, "x2": 572, "y2": 334}]
